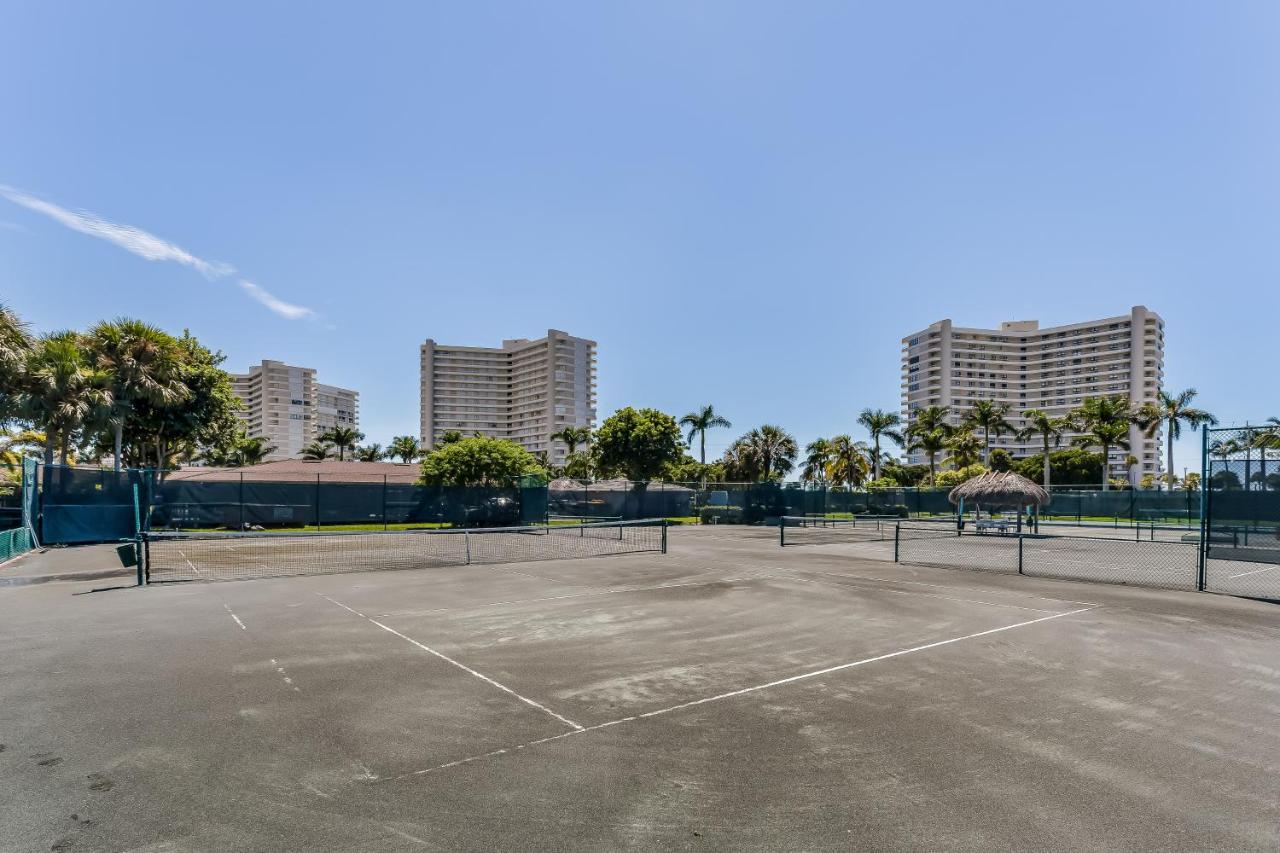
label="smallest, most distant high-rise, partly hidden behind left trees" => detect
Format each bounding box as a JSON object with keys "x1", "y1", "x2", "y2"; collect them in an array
[{"x1": 232, "y1": 359, "x2": 360, "y2": 461}]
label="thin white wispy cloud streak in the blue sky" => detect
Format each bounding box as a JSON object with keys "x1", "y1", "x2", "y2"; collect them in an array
[{"x1": 0, "y1": 183, "x2": 315, "y2": 320}]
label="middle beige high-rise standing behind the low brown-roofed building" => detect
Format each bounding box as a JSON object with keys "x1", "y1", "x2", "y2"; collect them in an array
[{"x1": 420, "y1": 329, "x2": 595, "y2": 465}]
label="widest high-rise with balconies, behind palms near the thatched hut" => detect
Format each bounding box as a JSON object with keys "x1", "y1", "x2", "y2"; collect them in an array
[{"x1": 902, "y1": 305, "x2": 1165, "y2": 482}]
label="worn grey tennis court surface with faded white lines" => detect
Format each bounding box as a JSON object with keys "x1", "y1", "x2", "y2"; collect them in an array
[{"x1": 0, "y1": 526, "x2": 1280, "y2": 850}]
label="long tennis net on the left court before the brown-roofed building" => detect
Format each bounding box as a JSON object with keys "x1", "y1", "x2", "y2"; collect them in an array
[{"x1": 142, "y1": 520, "x2": 667, "y2": 583}]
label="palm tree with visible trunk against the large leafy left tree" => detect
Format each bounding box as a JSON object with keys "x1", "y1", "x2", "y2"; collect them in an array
[{"x1": 86, "y1": 318, "x2": 189, "y2": 473}]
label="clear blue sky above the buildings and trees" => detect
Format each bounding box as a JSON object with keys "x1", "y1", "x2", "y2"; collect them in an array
[{"x1": 0, "y1": 0, "x2": 1280, "y2": 467}]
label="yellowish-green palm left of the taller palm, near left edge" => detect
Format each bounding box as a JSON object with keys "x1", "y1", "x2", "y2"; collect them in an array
[{"x1": 24, "y1": 332, "x2": 111, "y2": 465}]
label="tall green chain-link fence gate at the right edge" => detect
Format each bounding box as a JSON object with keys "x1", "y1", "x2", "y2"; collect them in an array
[{"x1": 1201, "y1": 424, "x2": 1280, "y2": 599}]
